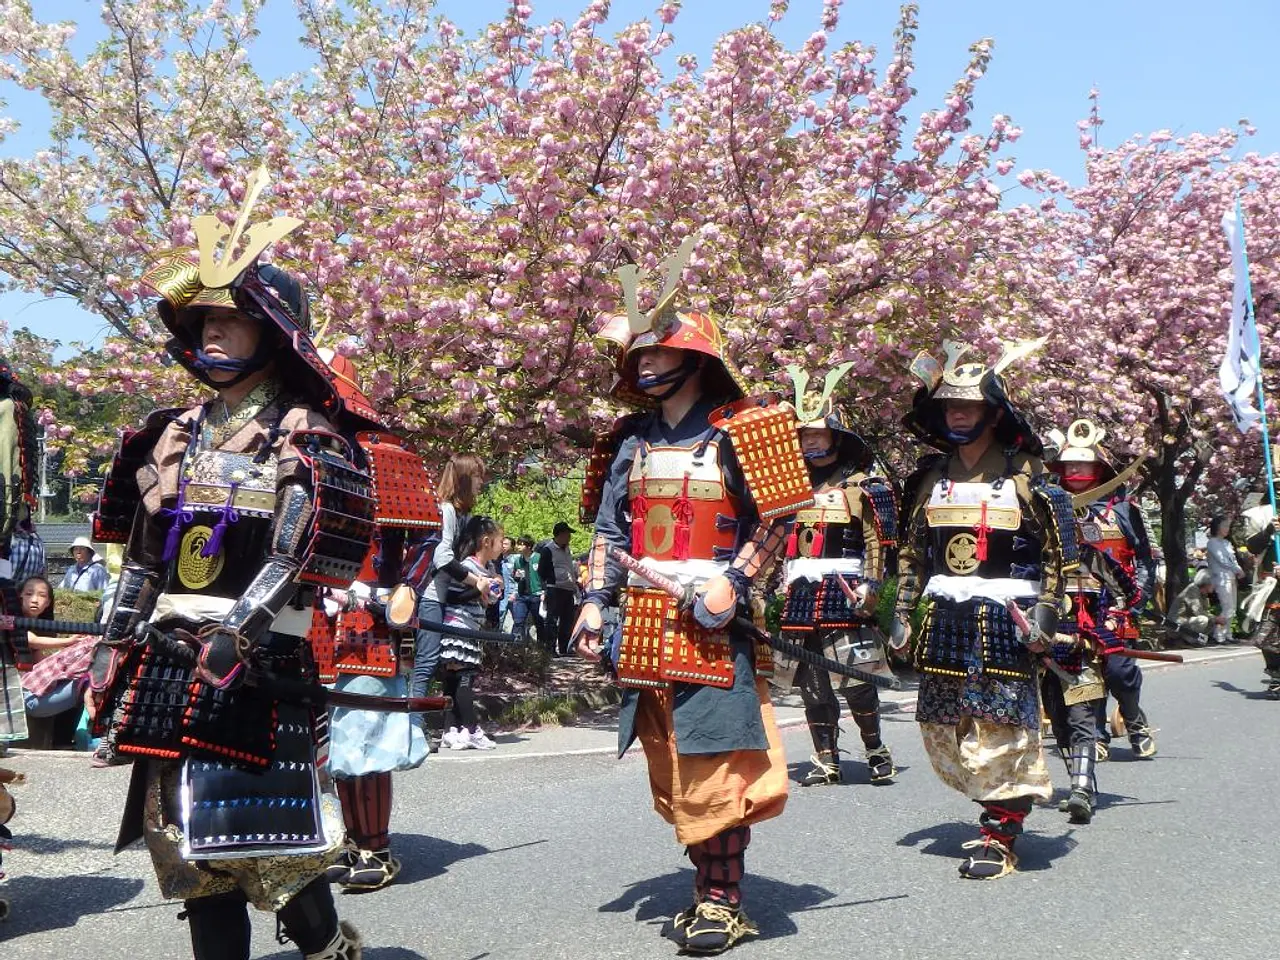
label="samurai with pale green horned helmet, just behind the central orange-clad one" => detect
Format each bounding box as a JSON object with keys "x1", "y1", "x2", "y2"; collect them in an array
[{"x1": 774, "y1": 364, "x2": 897, "y2": 786}]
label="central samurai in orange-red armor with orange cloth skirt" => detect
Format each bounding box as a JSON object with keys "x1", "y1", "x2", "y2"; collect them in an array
[{"x1": 573, "y1": 242, "x2": 813, "y2": 954}]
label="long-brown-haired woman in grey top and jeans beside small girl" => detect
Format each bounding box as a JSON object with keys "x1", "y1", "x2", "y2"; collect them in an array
[{"x1": 410, "y1": 453, "x2": 502, "y2": 721}]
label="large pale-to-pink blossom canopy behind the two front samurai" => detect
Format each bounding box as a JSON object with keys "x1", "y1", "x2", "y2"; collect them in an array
[{"x1": 0, "y1": 0, "x2": 1019, "y2": 478}]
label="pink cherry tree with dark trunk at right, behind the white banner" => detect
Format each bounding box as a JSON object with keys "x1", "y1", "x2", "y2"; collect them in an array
[{"x1": 993, "y1": 101, "x2": 1280, "y2": 601}]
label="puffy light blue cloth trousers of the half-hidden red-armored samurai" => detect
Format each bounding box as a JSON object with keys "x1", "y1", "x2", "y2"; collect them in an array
[{"x1": 329, "y1": 675, "x2": 428, "y2": 777}]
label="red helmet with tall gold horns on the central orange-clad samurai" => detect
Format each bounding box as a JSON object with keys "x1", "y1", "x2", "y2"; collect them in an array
[{"x1": 596, "y1": 237, "x2": 745, "y2": 407}]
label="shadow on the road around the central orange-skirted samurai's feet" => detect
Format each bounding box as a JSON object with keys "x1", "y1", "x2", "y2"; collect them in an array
[{"x1": 599, "y1": 870, "x2": 860, "y2": 940}]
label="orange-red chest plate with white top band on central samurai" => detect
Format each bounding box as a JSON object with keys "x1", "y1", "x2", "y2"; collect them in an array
[{"x1": 627, "y1": 443, "x2": 739, "y2": 561}]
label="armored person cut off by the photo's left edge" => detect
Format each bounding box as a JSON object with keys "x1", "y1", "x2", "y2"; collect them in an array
[{"x1": 0, "y1": 357, "x2": 36, "y2": 745}]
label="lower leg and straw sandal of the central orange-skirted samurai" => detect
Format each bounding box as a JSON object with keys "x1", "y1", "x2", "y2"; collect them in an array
[{"x1": 676, "y1": 827, "x2": 760, "y2": 955}]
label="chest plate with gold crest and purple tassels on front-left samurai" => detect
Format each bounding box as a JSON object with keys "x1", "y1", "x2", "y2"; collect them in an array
[{"x1": 165, "y1": 449, "x2": 276, "y2": 596}]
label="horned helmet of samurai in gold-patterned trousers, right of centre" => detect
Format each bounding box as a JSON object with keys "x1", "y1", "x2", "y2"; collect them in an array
[{"x1": 902, "y1": 337, "x2": 1048, "y2": 456}]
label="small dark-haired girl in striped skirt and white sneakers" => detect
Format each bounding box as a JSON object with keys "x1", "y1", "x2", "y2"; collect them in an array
[{"x1": 440, "y1": 517, "x2": 502, "y2": 750}]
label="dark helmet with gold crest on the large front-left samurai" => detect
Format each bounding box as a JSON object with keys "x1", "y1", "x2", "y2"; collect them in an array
[{"x1": 142, "y1": 166, "x2": 339, "y2": 412}]
